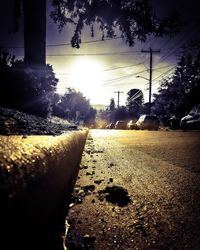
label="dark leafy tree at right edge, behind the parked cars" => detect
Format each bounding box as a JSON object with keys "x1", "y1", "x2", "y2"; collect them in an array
[{"x1": 152, "y1": 41, "x2": 200, "y2": 117}]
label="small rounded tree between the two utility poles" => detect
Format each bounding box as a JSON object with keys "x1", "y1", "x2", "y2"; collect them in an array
[{"x1": 126, "y1": 89, "x2": 144, "y2": 118}]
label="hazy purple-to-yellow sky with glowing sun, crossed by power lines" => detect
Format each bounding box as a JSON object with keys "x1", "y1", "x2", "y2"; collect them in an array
[{"x1": 0, "y1": 0, "x2": 200, "y2": 105}]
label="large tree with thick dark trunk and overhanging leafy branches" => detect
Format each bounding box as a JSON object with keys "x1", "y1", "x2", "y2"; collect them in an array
[{"x1": 15, "y1": 0, "x2": 178, "y2": 65}]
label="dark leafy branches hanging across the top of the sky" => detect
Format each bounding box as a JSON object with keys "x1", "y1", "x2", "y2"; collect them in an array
[{"x1": 51, "y1": 0, "x2": 179, "y2": 48}]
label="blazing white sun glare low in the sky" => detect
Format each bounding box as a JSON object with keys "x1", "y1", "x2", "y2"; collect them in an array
[{"x1": 57, "y1": 56, "x2": 106, "y2": 104}]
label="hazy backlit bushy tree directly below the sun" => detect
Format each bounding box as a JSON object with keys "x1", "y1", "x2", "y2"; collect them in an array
[{"x1": 52, "y1": 88, "x2": 96, "y2": 124}]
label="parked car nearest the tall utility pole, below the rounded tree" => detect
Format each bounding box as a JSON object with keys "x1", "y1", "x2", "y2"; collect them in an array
[{"x1": 136, "y1": 115, "x2": 160, "y2": 130}]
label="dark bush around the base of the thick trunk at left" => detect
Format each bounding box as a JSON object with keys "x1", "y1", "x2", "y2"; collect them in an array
[{"x1": 0, "y1": 50, "x2": 58, "y2": 117}]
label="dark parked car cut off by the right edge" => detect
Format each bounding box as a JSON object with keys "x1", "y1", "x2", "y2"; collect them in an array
[{"x1": 180, "y1": 104, "x2": 200, "y2": 130}]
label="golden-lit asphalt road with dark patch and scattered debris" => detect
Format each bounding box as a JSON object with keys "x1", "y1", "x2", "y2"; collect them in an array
[{"x1": 66, "y1": 130, "x2": 200, "y2": 250}]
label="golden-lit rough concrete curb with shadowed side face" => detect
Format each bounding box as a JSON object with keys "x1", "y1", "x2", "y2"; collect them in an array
[{"x1": 0, "y1": 130, "x2": 88, "y2": 250}]
